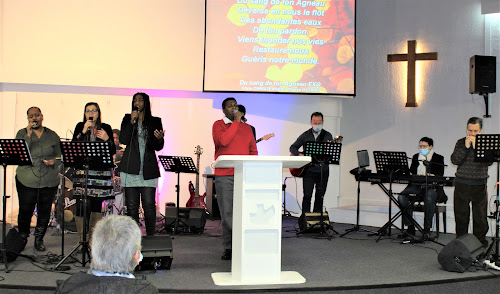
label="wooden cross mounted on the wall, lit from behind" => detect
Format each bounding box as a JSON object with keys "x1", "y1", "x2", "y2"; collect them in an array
[{"x1": 387, "y1": 40, "x2": 437, "y2": 107}]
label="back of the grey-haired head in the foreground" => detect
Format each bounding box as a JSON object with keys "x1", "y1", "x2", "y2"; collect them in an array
[{"x1": 90, "y1": 215, "x2": 141, "y2": 274}]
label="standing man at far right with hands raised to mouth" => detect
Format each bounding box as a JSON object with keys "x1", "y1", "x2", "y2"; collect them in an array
[{"x1": 451, "y1": 117, "x2": 493, "y2": 247}]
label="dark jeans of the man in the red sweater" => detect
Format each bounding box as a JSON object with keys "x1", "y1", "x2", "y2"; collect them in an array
[{"x1": 215, "y1": 176, "x2": 234, "y2": 249}]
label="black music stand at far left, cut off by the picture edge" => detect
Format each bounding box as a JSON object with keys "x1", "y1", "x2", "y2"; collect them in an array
[{"x1": 0, "y1": 139, "x2": 33, "y2": 273}]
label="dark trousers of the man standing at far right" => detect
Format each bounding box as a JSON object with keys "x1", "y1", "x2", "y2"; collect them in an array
[{"x1": 453, "y1": 182, "x2": 489, "y2": 246}]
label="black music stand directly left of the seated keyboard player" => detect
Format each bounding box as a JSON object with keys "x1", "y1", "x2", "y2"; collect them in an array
[{"x1": 373, "y1": 151, "x2": 414, "y2": 242}]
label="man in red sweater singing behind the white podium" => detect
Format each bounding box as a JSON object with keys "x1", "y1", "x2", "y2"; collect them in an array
[{"x1": 212, "y1": 97, "x2": 257, "y2": 260}]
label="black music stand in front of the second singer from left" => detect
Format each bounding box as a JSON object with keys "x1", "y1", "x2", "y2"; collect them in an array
[{"x1": 54, "y1": 141, "x2": 114, "y2": 270}]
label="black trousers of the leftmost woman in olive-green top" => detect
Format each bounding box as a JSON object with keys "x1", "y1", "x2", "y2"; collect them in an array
[{"x1": 16, "y1": 178, "x2": 57, "y2": 240}]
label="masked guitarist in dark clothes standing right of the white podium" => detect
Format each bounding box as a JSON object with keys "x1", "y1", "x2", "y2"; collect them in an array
[{"x1": 290, "y1": 112, "x2": 333, "y2": 215}]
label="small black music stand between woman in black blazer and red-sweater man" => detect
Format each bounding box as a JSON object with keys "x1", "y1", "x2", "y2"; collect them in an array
[{"x1": 158, "y1": 155, "x2": 198, "y2": 235}]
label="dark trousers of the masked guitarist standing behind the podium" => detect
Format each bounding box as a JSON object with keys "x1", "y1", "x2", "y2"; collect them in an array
[{"x1": 302, "y1": 169, "x2": 329, "y2": 214}]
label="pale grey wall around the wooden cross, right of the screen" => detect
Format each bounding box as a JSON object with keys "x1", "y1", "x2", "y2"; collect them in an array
[{"x1": 341, "y1": 0, "x2": 500, "y2": 234}]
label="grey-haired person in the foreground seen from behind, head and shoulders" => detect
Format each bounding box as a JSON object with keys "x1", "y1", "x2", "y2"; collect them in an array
[{"x1": 56, "y1": 215, "x2": 158, "y2": 293}]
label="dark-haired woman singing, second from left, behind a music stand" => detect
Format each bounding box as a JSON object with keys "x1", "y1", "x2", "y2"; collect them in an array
[{"x1": 73, "y1": 102, "x2": 116, "y2": 246}]
